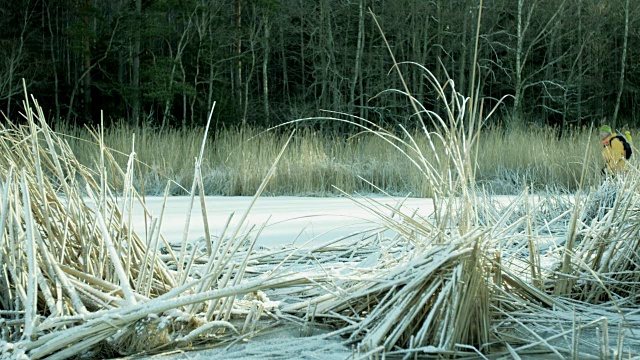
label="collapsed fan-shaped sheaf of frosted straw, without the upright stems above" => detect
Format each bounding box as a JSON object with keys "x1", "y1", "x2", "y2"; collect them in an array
[{"x1": 283, "y1": 228, "x2": 490, "y2": 351}]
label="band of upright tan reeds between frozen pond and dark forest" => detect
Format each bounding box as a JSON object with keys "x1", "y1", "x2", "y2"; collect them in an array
[{"x1": 56, "y1": 119, "x2": 600, "y2": 196}]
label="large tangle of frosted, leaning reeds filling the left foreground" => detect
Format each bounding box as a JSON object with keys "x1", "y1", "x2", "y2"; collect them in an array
[{"x1": 0, "y1": 90, "x2": 330, "y2": 359}]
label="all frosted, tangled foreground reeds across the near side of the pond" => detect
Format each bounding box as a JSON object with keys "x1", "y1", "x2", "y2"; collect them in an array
[{"x1": 0, "y1": 83, "x2": 640, "y2": 359}]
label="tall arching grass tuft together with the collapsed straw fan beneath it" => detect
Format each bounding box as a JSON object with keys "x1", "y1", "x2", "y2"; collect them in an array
[{"x1": 272, "y1": 7, "x2": 508, "y2": 356}]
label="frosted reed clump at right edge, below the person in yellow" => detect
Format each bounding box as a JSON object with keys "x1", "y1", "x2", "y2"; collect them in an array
[{"x1": 557, "y1": 176, "x2": 640, "y2": 306}]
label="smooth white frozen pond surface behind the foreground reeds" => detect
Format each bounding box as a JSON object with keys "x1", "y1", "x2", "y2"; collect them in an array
[{"x1": 133, "y1": 196, "x2": 440, "y2": 247}]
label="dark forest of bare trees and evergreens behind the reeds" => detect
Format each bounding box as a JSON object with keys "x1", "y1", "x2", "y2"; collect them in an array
[{"x1": 0, "y1": 0, "x2": 640, "y2": 131}]
